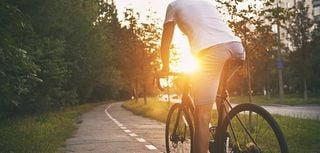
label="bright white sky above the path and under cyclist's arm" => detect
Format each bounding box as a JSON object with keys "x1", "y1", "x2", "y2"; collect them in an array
[{"x1": 114, "y1": 0, "x2": 196, "y2": 72}]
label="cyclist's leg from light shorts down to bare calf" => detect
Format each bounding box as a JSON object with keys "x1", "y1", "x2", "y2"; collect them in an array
[{"x1": 192, "y1": 45, "x2": 230, "y2": 153}]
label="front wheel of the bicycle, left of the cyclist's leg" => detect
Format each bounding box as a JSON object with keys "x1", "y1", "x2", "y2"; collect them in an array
[{"x1": 165, "y1": 103, "x2": 194, "y2": 153}]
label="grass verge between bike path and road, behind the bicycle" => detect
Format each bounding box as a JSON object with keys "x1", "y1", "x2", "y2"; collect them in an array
[{"x1": 122, "y1": 98, "x2": 320, "y2": 153}]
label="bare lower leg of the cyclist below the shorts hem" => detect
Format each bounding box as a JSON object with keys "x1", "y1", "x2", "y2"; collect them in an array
[{"x1": 193, "y1": 104, "x2": 212, "y2": 153}]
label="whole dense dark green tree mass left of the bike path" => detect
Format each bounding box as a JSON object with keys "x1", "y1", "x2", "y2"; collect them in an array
[{"x1": 0, "y1": 0, "x2": 131, "y2": 118}]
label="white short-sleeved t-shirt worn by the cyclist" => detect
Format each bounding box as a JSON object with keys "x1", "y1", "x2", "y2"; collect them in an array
[{"x1": 165, "y1": 0, "x2": 241, "y2": 55}]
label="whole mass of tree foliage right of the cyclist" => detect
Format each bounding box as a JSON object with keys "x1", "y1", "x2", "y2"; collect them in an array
[{"x1": 218, "y1": 0, "x2": 320, "y2": 99}]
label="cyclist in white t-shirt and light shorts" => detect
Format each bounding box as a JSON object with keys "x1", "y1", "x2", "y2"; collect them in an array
[{"x1": 159, "y1": 0, "x2": 245, "y2": 153}]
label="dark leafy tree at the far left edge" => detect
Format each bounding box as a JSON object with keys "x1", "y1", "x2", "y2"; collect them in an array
[{"x1": 0, "y1": 2, "x2": 42, "y2": 118}]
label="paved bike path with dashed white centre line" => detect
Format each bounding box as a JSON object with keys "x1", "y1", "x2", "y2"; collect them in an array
[{"x1": 65, "y1": 103, "x2": 165, "y2": 153}]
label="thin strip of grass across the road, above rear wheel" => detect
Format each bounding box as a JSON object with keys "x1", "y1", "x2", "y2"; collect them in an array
[{"x1": 230, "y1": 95, "x2": 320, "y2": 105}]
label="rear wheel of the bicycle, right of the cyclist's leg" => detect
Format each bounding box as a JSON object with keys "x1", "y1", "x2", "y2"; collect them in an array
[{"x1": 216, "y1": 103, "x2": 288, "y2": 153}]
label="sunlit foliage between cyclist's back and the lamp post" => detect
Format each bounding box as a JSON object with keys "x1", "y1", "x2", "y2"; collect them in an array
[{"x1": 218, "y1": 0, "x2": 290, "y2": 97}]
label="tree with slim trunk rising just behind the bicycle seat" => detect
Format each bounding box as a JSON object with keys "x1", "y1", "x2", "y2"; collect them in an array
[{"x1": 218, "y1": 0, "x2": 288, "y2": 101}]
